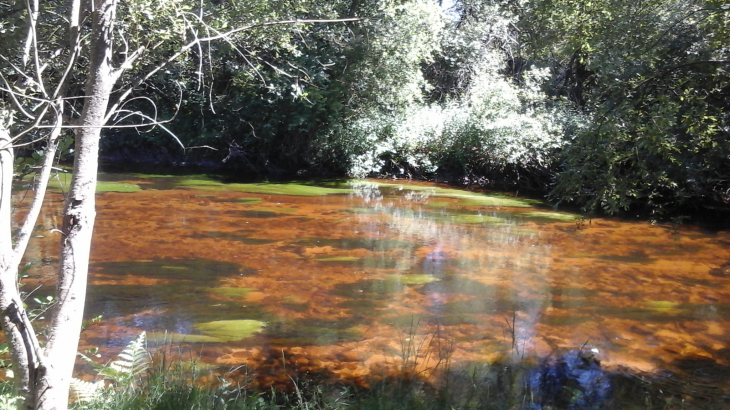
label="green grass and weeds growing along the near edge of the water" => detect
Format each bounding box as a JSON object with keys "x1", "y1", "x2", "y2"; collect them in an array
[{"x1": 0, "y1": 342, "x2": 712, "y2": 410}]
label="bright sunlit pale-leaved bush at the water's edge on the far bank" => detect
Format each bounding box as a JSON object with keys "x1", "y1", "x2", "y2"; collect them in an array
[{"x1": 330, "y1": 52, "x2": 582, "y2": 188}]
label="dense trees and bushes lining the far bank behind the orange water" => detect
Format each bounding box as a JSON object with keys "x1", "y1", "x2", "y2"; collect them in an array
[{"x1": 5, "y1": 0, "x2": 730, "y2": 216}]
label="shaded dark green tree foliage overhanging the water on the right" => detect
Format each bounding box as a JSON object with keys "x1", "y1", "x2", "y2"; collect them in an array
[{"x1": 536, "y1": 0, "x2": 730, "y2": 213}]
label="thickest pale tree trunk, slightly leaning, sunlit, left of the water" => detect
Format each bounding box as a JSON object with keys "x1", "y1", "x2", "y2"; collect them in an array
[{"x1": 35, "y1": 0, "x2": 118, "y2": 410}]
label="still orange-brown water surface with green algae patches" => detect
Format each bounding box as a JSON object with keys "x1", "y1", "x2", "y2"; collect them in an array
[{"x1": 16, "y1": 174, "x2": 730, "y2": 390}]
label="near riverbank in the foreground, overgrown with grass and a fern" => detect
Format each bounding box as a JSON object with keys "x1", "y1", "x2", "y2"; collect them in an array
[{"x1": 0, "y1": 346, "x2": 730, "y2": 410}]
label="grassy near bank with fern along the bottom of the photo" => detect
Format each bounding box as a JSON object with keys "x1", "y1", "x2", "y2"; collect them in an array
[{"x1": 59, "y1": 363, "x2": 729, "y2": 410}]
